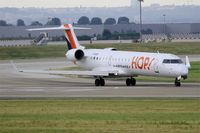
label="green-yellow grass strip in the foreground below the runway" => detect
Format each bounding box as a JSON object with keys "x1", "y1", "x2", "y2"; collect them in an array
[{"x1": 0, "y1": 98, "x2": 200, "y2": 133}]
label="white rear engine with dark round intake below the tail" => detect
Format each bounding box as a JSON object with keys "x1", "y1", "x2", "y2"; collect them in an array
[{"x1": 66, "y1": 49, "x2": 85, "y2": 61}]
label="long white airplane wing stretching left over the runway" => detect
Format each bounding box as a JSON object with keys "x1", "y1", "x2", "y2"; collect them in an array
[{"x1": 19, "y1": 70, "x2": 118, "y2": 77}]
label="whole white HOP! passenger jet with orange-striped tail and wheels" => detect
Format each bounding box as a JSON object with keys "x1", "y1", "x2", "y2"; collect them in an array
[{"x1": 29, "y1": 24, "x2": 190, "y2": 86}]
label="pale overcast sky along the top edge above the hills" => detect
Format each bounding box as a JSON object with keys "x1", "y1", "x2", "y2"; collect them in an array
[{"x1": 0, "y1": 0, "x2": 200, "y2": 8}]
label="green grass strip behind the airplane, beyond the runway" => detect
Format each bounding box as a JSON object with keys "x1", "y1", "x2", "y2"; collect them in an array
[{"x1": 0, "y1": 43, "x2": 200, "y2": 60}]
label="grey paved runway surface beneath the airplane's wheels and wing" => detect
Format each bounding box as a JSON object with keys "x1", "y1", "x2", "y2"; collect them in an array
[{"x1": 0, "y1": 58, "x2": 200, "y2": 99}]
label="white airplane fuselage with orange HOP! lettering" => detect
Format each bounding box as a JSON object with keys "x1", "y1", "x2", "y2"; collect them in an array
[{"x1": 68, "y1": 49, "x2": 188, "y2": 77}]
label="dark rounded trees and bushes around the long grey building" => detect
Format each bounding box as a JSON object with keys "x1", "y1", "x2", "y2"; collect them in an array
[{"x1": 0, "y1": 16, "x2": 153, "y2": 40}]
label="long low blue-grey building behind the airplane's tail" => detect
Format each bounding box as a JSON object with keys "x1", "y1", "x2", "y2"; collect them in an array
[{"x1": 0, "y1": 23, "x2": 200, "y2": 39}]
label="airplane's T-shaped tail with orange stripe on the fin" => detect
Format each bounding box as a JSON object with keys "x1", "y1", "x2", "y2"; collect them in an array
[{"x1": 27, "y1": 24, "x2": 90, "y2": 50}]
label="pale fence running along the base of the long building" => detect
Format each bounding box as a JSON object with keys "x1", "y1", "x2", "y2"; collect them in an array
[{"x1": 0, "y1": 33, "x2": 200, "y2": 47}]
